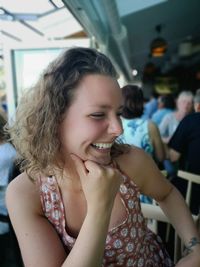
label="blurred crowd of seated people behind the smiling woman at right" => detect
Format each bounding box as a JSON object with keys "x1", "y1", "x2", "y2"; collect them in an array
[{"x1": 119, "y1": 84, "x2": 200, "y2": 214}]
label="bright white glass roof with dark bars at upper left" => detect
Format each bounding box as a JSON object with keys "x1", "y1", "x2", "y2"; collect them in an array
[{"x1": 0, "y1": 0, "x2": 82, "y2": 45}]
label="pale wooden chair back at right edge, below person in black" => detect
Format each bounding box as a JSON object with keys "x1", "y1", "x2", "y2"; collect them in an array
[{"x1": 178, "y1": 170, "x2": 200, "y2": 207}]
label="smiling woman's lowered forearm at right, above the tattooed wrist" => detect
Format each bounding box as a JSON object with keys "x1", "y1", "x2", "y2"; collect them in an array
[{"x1": 159, "y1": 187, "x2": 199, "y2": 245}]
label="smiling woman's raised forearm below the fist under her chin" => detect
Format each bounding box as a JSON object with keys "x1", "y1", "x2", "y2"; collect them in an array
[{"x1": 62, "y1": 210, "x2": 111, "y2": 267}]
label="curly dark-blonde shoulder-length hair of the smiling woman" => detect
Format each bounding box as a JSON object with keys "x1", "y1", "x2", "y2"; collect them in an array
[{"x1": 8, "y1": 47, "x2": 126, "y2": 178}]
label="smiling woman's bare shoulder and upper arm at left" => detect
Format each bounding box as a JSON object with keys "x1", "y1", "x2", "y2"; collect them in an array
[{"x1": 6, "y1": 173, "x2": 67, "y2": 267}]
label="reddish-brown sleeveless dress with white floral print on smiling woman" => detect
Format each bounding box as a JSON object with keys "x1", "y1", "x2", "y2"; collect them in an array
[{"x1": 40, "y1": 166, "x2": 174, "y2": 267}]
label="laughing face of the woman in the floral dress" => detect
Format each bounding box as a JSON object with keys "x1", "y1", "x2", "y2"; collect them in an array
[{"x1": 59, "y1": 74, "x2": 122, "y2": 165}]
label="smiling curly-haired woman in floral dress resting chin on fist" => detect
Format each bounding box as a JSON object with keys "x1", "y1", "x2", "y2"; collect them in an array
[{"x1": 6, "y1": 47, "x2": 200, "y2": 267}]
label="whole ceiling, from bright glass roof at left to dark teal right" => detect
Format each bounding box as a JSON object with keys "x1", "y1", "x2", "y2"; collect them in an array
[{"x1": 0, "y1": 0, "x2": 200, "y2": 84}]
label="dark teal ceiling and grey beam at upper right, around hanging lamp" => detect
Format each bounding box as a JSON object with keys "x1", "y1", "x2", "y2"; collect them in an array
[{"x1": 63, "y1": 0, "x2": 200, "y2": 81}]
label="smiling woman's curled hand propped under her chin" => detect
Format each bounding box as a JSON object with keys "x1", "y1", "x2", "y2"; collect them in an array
[{"x1": 72, "y1": 155, "x2": 122, "y2": 214}]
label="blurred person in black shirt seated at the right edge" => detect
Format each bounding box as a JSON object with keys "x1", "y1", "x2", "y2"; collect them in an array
[{"x1": 168, "y1": 94, "x2": 200, "y2": 214}]
